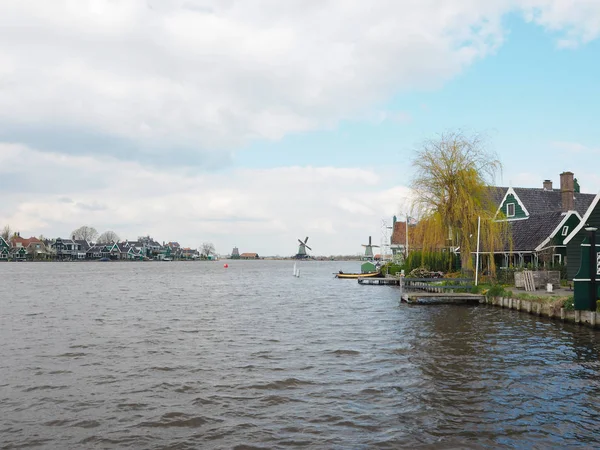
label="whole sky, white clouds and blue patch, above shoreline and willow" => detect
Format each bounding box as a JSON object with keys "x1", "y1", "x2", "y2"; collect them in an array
[{"x1": 0, "y1": 0, "x2": 600, "y2": 256}]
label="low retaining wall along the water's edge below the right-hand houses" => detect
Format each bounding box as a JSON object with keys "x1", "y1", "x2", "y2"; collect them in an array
[{"x1": 483, "y1": 297, "x2": 600, "y2": 328}]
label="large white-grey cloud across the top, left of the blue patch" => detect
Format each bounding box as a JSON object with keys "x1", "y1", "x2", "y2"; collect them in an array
[{"x1": 0, "y1": 0, "x2": 600, "y2": 163}]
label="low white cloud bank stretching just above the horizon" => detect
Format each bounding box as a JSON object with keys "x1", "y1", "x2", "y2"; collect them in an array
[{"x1": 0, "y1": 144, "x2": 409, "y2": 255}]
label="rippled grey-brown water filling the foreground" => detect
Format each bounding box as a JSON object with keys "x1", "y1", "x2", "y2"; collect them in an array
[{"x1": 0, "y1": 261, "x2": 600, "y2": 449}]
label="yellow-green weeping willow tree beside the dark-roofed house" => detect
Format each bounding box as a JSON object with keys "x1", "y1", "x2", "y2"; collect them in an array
[{"x1": 412, "y1": 131, "x2": 508, "y2": 269}]
